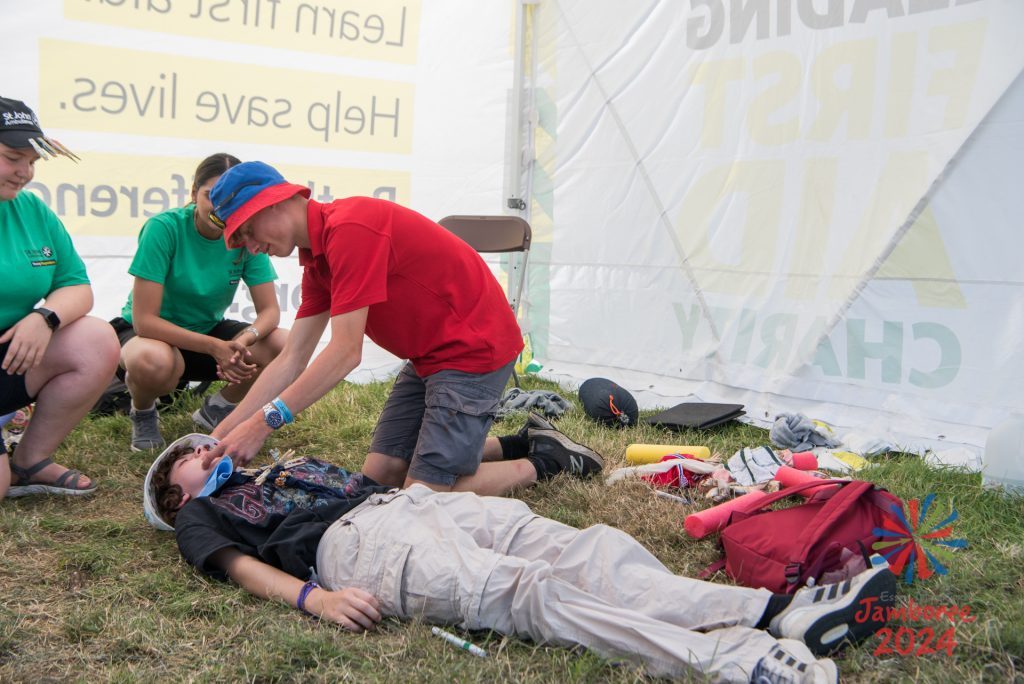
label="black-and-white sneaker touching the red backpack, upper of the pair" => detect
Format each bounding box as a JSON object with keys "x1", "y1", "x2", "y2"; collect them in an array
[{"x1": 768, "y1": 567, "x2": 896, "y2": 655}]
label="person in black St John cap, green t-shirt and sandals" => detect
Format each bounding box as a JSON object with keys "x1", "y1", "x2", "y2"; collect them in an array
[{"x1": 0, "y1": 97, "x2": 118, "y2": 500}]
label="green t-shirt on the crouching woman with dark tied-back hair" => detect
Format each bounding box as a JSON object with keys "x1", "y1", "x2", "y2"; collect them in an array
[{"x1": 121, "y1": 205, "x2": 278, "y2": 335}]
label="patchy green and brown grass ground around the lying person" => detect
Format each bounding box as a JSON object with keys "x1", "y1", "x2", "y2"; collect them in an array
[{"x1": 0, "y1": 379, "x2": 1024, "y2": 683}]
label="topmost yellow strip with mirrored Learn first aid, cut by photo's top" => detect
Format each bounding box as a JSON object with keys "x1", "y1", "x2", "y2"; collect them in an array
[{"x1": 63, "y1": 0, "x2": 420, "y2": 65}]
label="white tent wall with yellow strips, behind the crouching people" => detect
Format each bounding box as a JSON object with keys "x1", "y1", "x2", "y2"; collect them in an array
[{"x1": 0, "y1": 0, "x2": 513, "y2": 380}]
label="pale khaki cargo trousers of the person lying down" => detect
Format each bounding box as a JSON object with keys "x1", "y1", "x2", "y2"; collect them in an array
[{"x1": 316, "y1": 484, "x2": 776, "y2": 682}]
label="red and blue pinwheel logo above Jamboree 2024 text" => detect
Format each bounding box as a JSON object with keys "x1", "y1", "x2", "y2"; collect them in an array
[{"x1": 871, "y1": 494, "x2": 967, "y2": 585}]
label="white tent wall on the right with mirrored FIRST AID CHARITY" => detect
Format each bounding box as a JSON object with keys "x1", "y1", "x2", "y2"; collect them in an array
[{"x1": 520, "y1": 0, "x2": 1024, "y2": 451}]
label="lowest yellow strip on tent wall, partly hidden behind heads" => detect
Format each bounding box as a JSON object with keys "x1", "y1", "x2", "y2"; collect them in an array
[{"x1": 23, "y1": 153, "x2": 410, "y2": 237}]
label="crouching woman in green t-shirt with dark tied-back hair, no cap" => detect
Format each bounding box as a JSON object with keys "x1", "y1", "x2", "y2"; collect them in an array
[{"x1": 112, "y1": 153, "x2": 288, "y2": 452}]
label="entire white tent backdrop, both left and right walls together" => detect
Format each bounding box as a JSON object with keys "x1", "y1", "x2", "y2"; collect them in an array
[{"x1": 0, "y1": 0, "x2": 1024, "y2": 458}]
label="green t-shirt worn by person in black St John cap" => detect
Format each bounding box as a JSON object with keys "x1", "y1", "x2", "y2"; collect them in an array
[{"x1": 0, "y1": 190, "x2": 89, "y2": 330}]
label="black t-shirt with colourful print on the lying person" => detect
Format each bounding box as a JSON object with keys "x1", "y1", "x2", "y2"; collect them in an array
[{"x1": 174, "y1": 459, "x2": 391, "y2": 580}]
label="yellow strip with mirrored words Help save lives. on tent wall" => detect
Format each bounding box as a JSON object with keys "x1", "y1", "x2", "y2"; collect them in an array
[{"x1": 39, "y1": 39, "x2": 414, "y2": 154}]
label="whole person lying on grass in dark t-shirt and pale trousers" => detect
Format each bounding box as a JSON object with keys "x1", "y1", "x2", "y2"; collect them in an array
[{"x1": 143, "y1": 435, "x2": 896, "y2": 682}]
